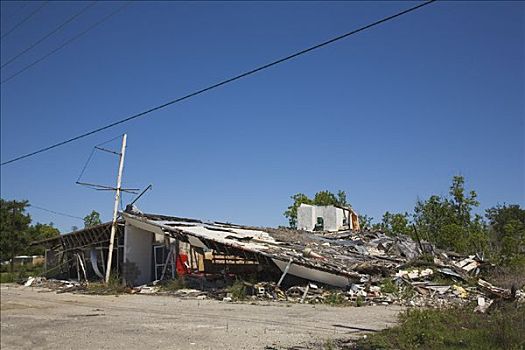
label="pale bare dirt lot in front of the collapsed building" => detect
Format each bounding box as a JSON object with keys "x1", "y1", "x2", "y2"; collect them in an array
[{"x1": 0, "y1": 285, "x2": 401, "y2": 350}]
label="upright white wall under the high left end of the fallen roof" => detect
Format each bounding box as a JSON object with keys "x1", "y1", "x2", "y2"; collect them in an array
[{"x1": 124, "y1": 224, "x2": 154, "y2": 285}]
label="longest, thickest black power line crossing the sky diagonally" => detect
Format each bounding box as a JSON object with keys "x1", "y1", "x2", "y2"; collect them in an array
[{"x1": 0, "y1": 0, "x2": 436, "y2": 165}]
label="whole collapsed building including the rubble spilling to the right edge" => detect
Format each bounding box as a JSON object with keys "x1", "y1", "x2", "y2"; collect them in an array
[{"x1": 33, "y1": 207, "x2": 525, "y2": 312}]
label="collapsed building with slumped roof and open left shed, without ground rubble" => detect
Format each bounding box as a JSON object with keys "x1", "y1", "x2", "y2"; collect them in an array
[{"x1": 35, "y1": 208, "x2": 438, "y2": 288}]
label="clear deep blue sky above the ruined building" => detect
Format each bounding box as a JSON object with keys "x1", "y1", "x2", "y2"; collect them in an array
[{"x1": 0, "y1": 1, "x2": 525, "y2": 232}]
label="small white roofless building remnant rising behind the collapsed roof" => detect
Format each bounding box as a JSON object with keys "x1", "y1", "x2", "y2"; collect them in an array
[{"x1": 297, "y1": 204, "x2": 359, "y2": 232}]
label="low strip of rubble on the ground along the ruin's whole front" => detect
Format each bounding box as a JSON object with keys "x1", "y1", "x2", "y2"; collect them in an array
[{"x1": 19, "y1": 268, "x2": 525, "y2": 312}]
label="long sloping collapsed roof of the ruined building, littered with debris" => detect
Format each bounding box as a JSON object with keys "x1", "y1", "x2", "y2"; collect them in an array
[{"x1": 122, "y1": 212, "x2": 421, "y2": 287}]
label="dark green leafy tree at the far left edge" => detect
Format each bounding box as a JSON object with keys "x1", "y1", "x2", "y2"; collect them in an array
[{"x1": 0, "y1": 199, "x2": 31, "y2": 272}]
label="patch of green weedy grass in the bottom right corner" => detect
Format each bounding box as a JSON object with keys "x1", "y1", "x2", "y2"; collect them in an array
[{"x1": 354, "y1": 303, "x2": 525, "y2": 349}]
